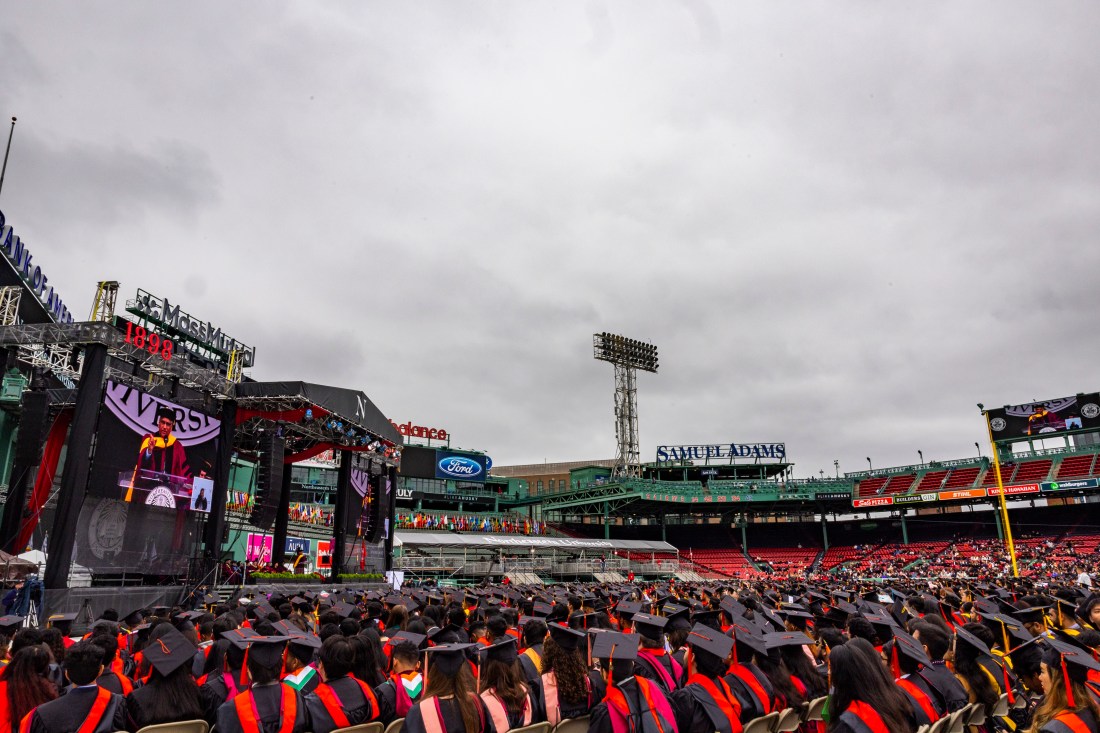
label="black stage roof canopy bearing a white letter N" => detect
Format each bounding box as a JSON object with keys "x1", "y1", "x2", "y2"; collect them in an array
[{"x1": 235, "y1": 382, "x2": 404, "y2": 446}]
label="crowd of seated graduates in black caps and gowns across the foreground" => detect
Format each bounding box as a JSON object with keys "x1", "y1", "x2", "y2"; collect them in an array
[{"x1": 0, "y1": 580, "x2": 1100, "y2": 733}]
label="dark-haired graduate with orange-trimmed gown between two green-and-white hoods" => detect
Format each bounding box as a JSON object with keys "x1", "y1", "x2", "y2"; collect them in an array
[{"x1": 306, "y1": 635, "x2": 383, "y2": 733}]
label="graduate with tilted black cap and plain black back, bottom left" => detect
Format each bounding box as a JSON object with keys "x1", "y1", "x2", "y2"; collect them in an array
[{"x1": 127, "y1": 628, "x2": 216, "y2": 730}]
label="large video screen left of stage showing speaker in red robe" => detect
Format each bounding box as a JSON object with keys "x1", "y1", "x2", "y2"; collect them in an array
[{"x1": 75, "y1": 381, "x2": 224, "y2": 575}]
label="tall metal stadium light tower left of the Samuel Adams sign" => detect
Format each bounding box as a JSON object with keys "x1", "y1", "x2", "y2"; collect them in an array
[{"x1": 592, "y1": 331, "x2": 658, "y2": 475}]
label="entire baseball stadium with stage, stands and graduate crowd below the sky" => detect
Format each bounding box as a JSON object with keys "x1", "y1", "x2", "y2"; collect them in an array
[{"x1": 0, "y1": 203, "x2": 1100, "y2": 733}]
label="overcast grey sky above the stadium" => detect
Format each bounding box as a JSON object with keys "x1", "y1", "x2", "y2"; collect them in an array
[{"x1": 0, "y1": 0, "x2": 1100, "y2": 477}]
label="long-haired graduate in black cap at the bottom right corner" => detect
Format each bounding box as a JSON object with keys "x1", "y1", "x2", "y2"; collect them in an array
[{"x1": 1029, "y1": 638, "x2": 1100, "y2": 733}]
